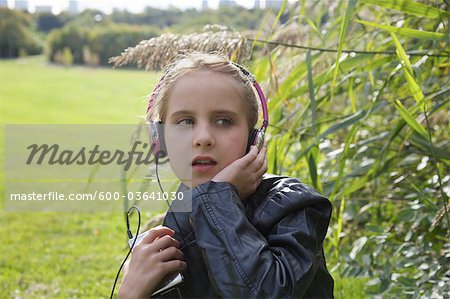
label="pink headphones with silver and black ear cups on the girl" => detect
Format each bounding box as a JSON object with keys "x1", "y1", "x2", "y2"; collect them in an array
[{"x1": 147, "y1": 61, "x2": 269, "y2": 161}]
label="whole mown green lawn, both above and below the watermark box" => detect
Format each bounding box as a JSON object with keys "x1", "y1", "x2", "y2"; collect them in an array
[{"x1": 0, "y1": 57, "x2": 365, "y2": 298}]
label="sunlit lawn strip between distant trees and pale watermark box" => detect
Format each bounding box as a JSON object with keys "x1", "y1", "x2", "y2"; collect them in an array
[{"x1": 0, "y1": 57, "x2": 152, "y2": 124}]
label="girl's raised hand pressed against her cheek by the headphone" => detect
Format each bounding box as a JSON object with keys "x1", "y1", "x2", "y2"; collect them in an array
[{"x1": 212, "y1": 145, "x2": 267, "y2": 199}]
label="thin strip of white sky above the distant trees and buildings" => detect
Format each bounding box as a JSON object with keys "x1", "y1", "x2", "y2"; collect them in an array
[{"x1": 2, "y1": 0, "x2": 265, "y2": 13}]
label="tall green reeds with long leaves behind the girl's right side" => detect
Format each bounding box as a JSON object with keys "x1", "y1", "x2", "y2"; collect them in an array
[{"x1": 252, "y1": 0, "x2": 450, "y2": 296}]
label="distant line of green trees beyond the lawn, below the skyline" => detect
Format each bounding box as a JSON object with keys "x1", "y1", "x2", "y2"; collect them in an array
[{"x1": 0, "y1": 6, "x2": 274, "y2": 65}]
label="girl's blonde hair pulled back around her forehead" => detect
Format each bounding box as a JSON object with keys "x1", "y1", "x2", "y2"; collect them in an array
[{"x1": 147, "y1": 52, "x2": 258, "y2": 130}]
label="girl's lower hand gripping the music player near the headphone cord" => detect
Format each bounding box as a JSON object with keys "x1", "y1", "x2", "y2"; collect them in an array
[{"x1": 119, "y1": 226, "x2": 186, "y2": 298}]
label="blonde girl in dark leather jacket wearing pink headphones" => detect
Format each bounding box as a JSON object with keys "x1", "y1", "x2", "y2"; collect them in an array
[{"x1": 119, "y1": 53, "x2": 333, "y2": 298}]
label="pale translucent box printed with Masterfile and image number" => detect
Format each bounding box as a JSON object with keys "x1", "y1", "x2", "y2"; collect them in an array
[{"x1": 5, "y1": 125, "x2": 192, "y2": 212}]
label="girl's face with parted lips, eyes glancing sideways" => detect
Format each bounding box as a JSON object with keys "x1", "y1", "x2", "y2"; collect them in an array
[{"x1": 164, "y1": 71, "x2": 249, "y2": 187}]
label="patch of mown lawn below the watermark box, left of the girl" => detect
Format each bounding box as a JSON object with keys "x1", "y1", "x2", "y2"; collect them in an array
[{"x1": 0, "y1": 211, "x2": 125, "y2": 298}]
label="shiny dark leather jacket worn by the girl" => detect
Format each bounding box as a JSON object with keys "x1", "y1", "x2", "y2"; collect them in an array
[{"x1": 164, "y1": 175, "x2": 334, "y2": 298}]
